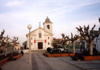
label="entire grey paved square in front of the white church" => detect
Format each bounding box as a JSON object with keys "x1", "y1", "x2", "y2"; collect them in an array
[{"x1": 2, "y1": 52, "x2": 100, "y2": 70}]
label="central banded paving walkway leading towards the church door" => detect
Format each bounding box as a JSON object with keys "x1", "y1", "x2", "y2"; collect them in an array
[{"x1": 32, "y1": 53, "x2": 81, "y2": 70}]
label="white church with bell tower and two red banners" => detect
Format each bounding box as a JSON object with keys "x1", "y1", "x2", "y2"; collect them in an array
[{"x1": 26, "y1": 17, "x2": 53, "y2": 50}]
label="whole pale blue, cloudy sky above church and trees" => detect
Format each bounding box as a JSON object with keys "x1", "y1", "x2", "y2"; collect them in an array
[{"x1": 0, "y1": 0, "x2": 100, "y2": 44}]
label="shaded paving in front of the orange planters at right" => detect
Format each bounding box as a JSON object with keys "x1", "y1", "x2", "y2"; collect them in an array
[{"x1": 59, "y1": 57, "x2": 100, "y2": 70}]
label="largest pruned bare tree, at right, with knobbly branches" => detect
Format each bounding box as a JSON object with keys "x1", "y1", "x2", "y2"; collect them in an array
[{"x1": 76, "y1": 25, "x2": 96, "y2": 55}]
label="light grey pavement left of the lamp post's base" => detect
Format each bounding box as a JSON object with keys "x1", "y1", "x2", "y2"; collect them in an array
[{"x1": 1, "y1": 54, "x2": 32, "y2": 70}]
